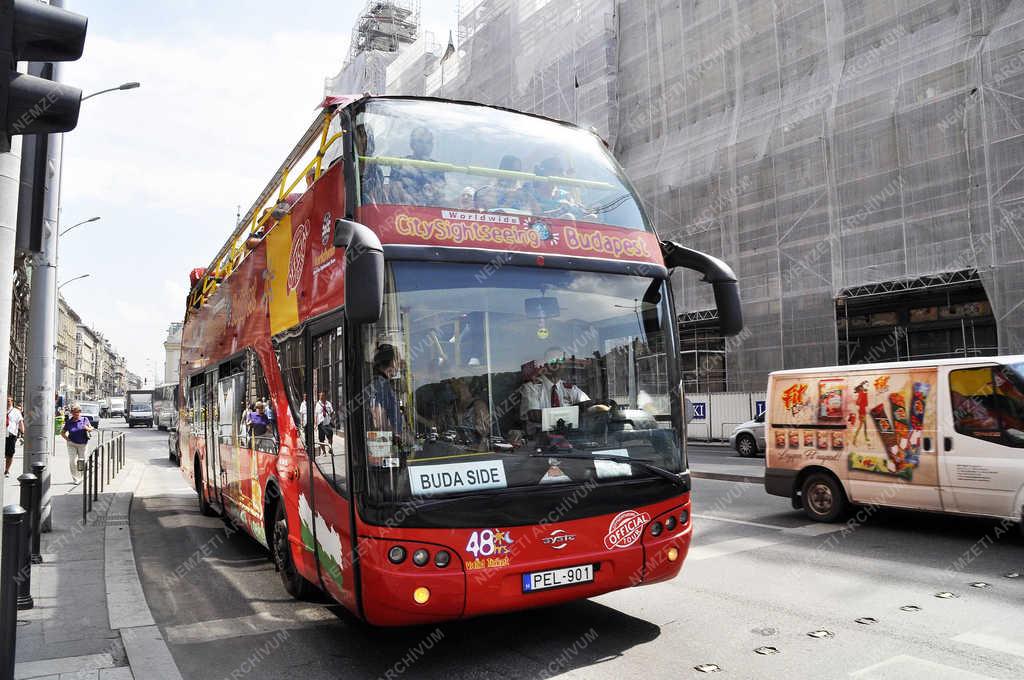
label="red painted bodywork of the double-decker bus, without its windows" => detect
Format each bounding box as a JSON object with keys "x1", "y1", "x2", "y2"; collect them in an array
[{"x1": 178, "y1": 99, "x2": 691, "y2": 626}]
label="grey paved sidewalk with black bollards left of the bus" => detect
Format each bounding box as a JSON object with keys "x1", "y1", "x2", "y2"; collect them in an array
[{"x1": 4, "y1": 437, "x2": 181, "y2": 680}]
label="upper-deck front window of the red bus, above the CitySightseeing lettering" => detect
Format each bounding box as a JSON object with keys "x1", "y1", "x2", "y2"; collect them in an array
[{"x1": 355, "y1": 99, "x2": 644, "y2": 229}]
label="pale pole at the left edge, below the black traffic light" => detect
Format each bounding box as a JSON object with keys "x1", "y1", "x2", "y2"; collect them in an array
[{"x1": 0, "y1": 137, "x2": 22, "y2": 516}]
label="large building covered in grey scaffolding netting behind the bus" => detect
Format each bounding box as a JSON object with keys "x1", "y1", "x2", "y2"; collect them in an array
[{"x1": 342, "y1": 0, "x2": 1024, "y2": 391}]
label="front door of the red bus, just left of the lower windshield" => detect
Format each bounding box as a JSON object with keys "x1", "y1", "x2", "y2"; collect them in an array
[{"x1": 306, "y1": 314, "x2": 355, "y2": 607}]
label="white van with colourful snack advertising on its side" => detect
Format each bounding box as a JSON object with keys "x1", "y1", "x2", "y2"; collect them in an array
[{"x1": 765, "y1": 355, "x2": 1024, "y2": 521}]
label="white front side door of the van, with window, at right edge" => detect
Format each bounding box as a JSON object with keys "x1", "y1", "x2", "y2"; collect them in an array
[{"x1": 939, "y1": 363, "x2": 1024, "y2": 518}]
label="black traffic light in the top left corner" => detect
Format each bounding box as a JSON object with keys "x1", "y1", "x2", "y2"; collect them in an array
[{"x1": 0, "y1": 0, "x2": 89, "y2": 152}]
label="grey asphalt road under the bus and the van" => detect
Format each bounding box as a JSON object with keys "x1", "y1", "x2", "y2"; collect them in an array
[{"x1": 121, "y1": 429, "x2": 1024, "y2": 680}]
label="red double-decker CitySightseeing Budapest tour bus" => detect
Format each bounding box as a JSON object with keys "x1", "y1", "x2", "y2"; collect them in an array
[{"x1": 177, "y1": 96, "x2": 741, "y2": 626}]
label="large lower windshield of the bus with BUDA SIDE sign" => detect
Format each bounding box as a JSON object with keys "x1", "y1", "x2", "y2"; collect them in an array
[{"x1": 360, "y1": 262, "x2": 683, "y2": 502}]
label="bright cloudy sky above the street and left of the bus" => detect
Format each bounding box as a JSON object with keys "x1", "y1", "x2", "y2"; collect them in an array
[{"x1": 57, "y1": 0, "x2": 456, "y2": 384}]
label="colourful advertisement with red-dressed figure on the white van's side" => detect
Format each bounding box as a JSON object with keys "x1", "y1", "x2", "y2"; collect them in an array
[{"x1": 766, "y1": 369, "x2": 938, "y2": 485}]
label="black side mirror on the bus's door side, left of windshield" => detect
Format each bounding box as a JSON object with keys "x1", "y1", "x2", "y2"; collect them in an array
[{"x1": 334, "y1": 219, "x2": 384, "y2": 324}]
